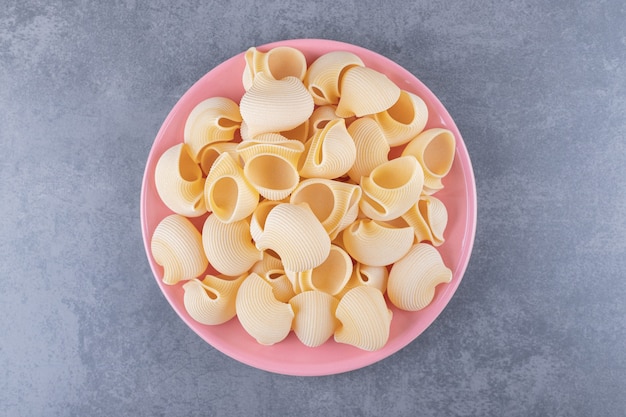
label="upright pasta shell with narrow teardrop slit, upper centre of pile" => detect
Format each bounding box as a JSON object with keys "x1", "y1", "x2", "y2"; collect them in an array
[{"x1": 299, "y1": 119, "x2": 356, "y2": 179}]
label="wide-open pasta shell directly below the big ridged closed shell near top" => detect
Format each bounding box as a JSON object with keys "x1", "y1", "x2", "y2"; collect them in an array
[{"x1": 237, "y1": 135, "x2": 304, "y2": 200}]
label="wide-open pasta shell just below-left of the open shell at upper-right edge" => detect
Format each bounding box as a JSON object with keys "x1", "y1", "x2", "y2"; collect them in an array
[{"x1": 359, "y1": 156, "x2": 424, "y2": 220}]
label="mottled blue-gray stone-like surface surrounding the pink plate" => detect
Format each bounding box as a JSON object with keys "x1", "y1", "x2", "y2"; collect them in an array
[{"x1": 0, "y1": 0, "x2": 626, "y2": 417}]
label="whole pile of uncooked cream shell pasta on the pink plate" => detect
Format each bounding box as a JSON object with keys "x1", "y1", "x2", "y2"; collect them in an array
[{"x1": 151, "y1": 46, "x2": 455, "y2": 351}]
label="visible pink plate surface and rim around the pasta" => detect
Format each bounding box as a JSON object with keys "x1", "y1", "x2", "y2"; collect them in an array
[{"x1": 141, "y1": 39, "x2": 476, "y2": 376}]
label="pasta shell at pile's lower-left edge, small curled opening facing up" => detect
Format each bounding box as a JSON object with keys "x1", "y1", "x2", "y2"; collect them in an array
[{"x1": 183, "y1": 275, "x2": 246, "y2": 325}]
